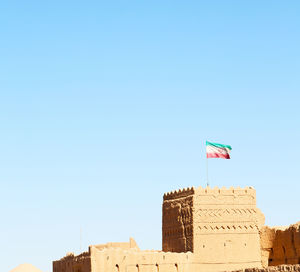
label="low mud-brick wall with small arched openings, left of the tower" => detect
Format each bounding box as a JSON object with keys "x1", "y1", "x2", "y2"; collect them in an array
[{"x1": 53, "y1": 238, "x2": 197, "y2": 272}]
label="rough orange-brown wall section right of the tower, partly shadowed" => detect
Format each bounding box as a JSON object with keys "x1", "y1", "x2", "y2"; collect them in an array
[{"x1": 260, "y1": 222, "x2": 300, "y2": 267}]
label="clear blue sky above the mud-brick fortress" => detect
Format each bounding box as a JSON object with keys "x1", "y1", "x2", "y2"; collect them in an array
[{"x1": 0, "y1": 0, "x2": 300, "y2": 272}]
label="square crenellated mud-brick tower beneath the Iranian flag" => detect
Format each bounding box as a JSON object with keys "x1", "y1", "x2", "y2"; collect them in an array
[{"x1": 162, "y1": 187, "x2": 265, "y2": 268}]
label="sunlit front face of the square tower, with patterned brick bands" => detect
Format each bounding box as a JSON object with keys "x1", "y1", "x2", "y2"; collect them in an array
[{"x1": 193, "y1": 187, "x2": 264, "y2": 270}]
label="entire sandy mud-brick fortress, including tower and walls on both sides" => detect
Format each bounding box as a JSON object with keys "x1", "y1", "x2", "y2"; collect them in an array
[{"x1": 53, "y1": 187, "x2": 300, "y2": 272}]
